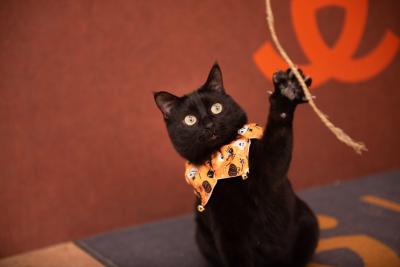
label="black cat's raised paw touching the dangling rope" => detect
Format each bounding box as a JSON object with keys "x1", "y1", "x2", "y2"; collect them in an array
[{"x1": 272, "y1": 68, "x2": 312, "y2": 104}]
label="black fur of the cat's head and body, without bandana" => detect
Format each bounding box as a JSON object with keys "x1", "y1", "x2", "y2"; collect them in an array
[{"x1": 154, "y1": 64, "x2": 319, "y2": 267}]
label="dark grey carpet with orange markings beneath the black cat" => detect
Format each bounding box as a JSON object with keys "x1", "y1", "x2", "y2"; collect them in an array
[{"x1": 76, "y1": 172, "x2": 400, "y2": 267}]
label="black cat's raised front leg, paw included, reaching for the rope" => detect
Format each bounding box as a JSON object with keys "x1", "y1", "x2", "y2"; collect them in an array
[{"x1": 250, "y1": 69, "x2": 311, "y2": 186}]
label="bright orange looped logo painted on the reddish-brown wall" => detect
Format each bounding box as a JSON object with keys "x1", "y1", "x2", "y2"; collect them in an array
[{"x1": 253, "y1": 0, "x2": 400, "y2": 88}]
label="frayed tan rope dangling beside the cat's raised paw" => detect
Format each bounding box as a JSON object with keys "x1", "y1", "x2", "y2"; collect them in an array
[{"x1": 266, "y1": 0, "x2": 368, "y2": 154}]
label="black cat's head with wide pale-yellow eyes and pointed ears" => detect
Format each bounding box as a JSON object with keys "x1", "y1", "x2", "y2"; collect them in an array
[{"x1": 154, "y1": 63, "x2": 247, "y2": 164}]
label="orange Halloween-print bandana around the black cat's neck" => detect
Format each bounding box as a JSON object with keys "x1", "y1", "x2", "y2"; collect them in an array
[{"x1": 185, "y1": 123, "x2": 263, "y2": 212}]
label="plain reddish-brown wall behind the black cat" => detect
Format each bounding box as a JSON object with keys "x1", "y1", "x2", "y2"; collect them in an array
[{"x1": 0, "y1": 0, "x2": 400, "y2": 256}]
